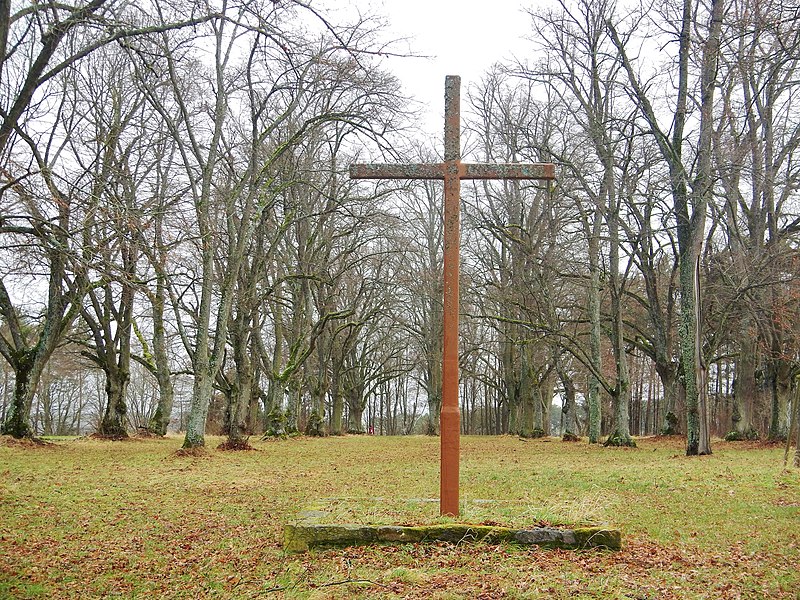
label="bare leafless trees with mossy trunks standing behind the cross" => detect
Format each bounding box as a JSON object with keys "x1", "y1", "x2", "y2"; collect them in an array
[{"x1": 0, "y1": 0, "x2": 800, "y2": 454}]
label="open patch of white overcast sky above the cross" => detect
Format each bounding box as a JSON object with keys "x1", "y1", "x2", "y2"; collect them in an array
[{"x1": 350, "y1": 0, "x2": 535, "y2": 136}]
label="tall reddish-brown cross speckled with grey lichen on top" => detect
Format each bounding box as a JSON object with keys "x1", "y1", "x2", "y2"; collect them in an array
[{"x1": 350, "y1": 75, "x2": 555, "y2": 516}]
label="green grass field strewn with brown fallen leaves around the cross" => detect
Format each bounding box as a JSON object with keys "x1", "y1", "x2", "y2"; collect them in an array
[{"x1": 0, "y1": 436, "x2": 800, "y2": 600}]
